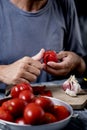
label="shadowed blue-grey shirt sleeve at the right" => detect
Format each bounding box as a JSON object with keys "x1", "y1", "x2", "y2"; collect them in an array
[{"x1": 62, "y1": 0, "x2": 86, "y2": 57}]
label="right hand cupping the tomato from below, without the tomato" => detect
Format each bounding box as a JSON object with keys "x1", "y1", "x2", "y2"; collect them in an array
[{"x1": 44, "y1": 51, "x2": 86, "y2": 76}]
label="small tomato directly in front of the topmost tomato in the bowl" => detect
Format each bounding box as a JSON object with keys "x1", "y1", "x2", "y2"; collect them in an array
[{"x1": 19, "y1": 90, "x2": 35, "y2": 103}]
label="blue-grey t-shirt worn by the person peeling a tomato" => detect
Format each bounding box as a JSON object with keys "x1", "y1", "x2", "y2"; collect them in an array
[{"x1": 0, "y1": 0, "x2": 85, "y2": 88}]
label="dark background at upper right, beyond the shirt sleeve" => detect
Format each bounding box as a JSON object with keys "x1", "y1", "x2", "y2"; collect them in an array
[{"x1": 74, "y1": 0, "x2": 87, "y2": 51}]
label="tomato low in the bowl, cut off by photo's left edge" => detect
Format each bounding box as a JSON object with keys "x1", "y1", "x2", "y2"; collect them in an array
[{"x1": 0, "y1": 107, "x2": 13, "y2": 122}]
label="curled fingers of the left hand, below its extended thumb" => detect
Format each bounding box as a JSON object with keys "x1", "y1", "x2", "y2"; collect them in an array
[{"x1": 19, "y1": 59, "x2": 43, "y2": 82}]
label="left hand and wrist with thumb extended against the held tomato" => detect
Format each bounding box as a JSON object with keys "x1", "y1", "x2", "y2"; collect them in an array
[{"x1": 0, "y1": 49, "x2": 45, "y2": 85}]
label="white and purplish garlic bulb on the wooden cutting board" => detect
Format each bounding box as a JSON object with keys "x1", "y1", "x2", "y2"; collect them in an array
[{"x1": 62, "y1": 75, "x2": 82, "y2": 97}]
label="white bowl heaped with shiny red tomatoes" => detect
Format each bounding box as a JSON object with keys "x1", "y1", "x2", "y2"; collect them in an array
[{"x1": 0, "y1": 84, "x2": 73, "y2": 130}]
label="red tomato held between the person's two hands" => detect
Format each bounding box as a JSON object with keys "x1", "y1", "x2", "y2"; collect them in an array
[{"x1": 43, "y1": 50, "x2": 58, "y2": 64}]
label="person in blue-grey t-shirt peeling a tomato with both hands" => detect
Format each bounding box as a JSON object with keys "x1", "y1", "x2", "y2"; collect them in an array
[{"x1": 0, "y1": 0, "x2": 86, "y2": 88}]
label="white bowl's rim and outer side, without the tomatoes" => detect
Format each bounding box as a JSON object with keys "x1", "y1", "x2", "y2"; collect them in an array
[{"x1": 0, "y1": 97, "x2": 73, "y2": 130}]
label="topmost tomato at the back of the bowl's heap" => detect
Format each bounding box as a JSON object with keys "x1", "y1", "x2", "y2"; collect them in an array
[{"x1": 11, "y1": 83, "x2": 33, "y2": 98}]
